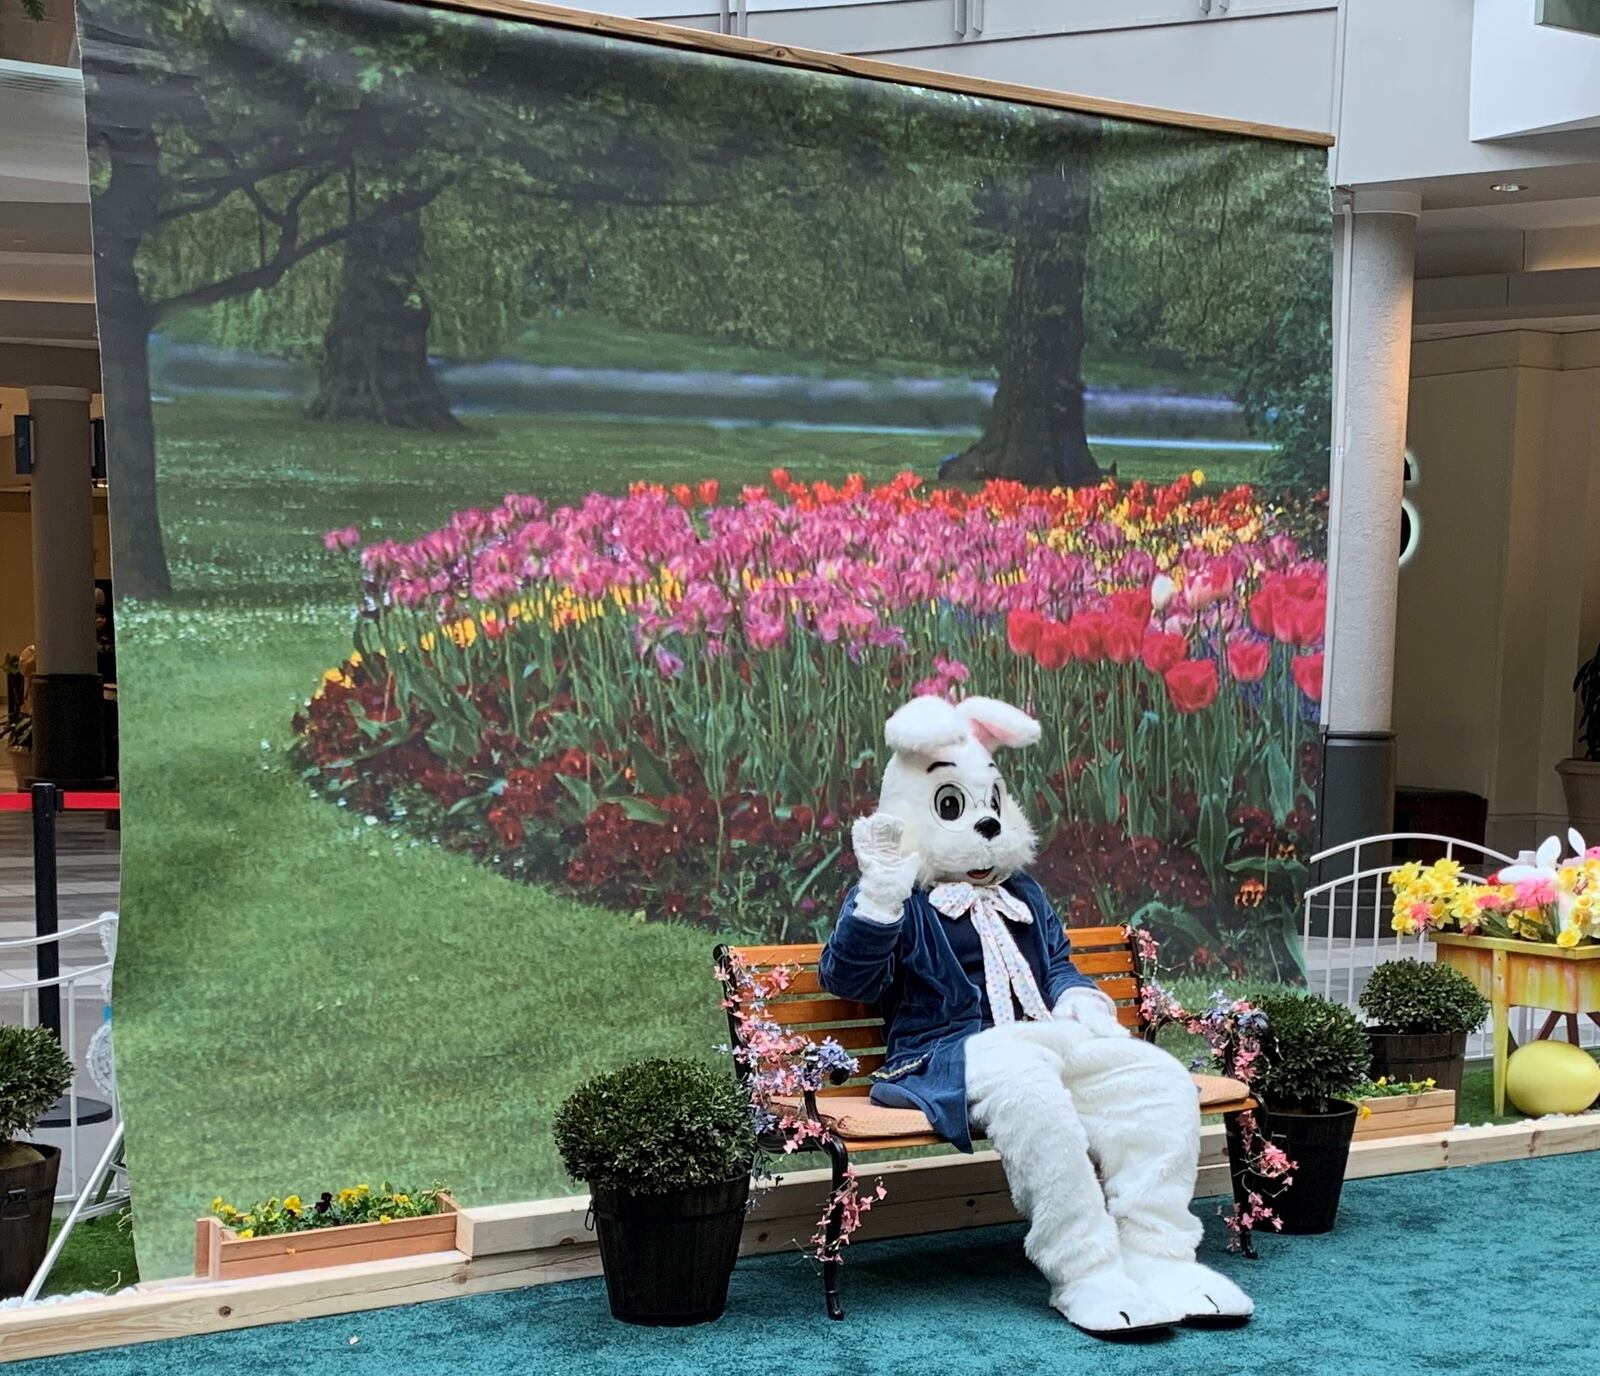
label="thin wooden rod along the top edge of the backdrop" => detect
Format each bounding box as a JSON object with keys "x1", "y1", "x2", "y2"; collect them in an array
[{"x1": 397, "y1": 0, "x2": 1333, "y2": 149}]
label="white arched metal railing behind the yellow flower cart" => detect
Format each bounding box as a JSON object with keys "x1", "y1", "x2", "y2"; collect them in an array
[{"x1": 1301, "y1": 832, "x2": 1574, "y2": 1059}]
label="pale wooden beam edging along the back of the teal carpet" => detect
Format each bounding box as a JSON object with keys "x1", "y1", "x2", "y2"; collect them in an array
[{"x1": 0, "y1": 1114, "x2": 1600, "y2": 1365}]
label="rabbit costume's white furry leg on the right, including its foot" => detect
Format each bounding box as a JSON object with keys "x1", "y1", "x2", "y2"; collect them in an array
[{"x1": 1067, "y1": 1038, "x2": 1254, "y2": 1322}]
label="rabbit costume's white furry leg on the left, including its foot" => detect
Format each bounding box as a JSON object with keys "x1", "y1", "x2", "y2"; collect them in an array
[{"x1": 966, "y1": 1024, "x2": 1182, "y2": 1334}]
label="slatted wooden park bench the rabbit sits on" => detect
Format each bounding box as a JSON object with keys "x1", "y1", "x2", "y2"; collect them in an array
[{"x1": 717, "y1": 926, "x2": 1256, "y2": 1318}]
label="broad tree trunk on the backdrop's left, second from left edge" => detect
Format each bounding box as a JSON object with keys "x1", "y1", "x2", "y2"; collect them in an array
[{"x1": 309, "y1": 211, "x2": 458, "y2": 430}]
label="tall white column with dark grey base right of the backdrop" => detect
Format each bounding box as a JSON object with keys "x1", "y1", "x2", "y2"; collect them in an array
[{"x1": 1318, "y1": 190, "x2": 1422, "y2": 931}]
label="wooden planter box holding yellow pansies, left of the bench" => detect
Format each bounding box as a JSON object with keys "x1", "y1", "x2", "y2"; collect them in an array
[{"x1": 195, "y1": 1195, "x2": 458, "y2": 1280}]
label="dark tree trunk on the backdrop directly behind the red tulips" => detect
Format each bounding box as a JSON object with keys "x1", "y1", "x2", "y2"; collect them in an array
[{"x1": 941, "y1": 149, "x2": 1099, "y2": 488}]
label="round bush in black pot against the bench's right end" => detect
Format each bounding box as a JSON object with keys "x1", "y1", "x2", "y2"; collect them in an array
[{"x1": 1251, "y1": 994, "x2": 1371, "y2": 1234}]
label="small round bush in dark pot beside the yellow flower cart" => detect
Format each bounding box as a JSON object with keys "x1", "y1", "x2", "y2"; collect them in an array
[{"x1": 1360, "y1": 960, "x2": 1490, "y2": 1093}]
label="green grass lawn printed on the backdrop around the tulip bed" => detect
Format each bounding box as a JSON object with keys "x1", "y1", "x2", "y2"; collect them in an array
[{"x1": 117, "y1": 398, "x2": 1273, "y2": 1277}]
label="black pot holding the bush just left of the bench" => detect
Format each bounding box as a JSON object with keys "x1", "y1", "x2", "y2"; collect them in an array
[{"x1": 590, "y1": 1176, "x2": 750, "y2": 1326}]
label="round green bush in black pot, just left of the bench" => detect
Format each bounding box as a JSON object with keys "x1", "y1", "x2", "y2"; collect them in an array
[{"x1": 555, "y1": 1061, "x2": 755, "y2": 1325}]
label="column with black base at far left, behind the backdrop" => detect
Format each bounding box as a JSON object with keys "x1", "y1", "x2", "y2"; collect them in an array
[{"x1": 27, "y1": 387, "x2": 106, "y2": 787}]
